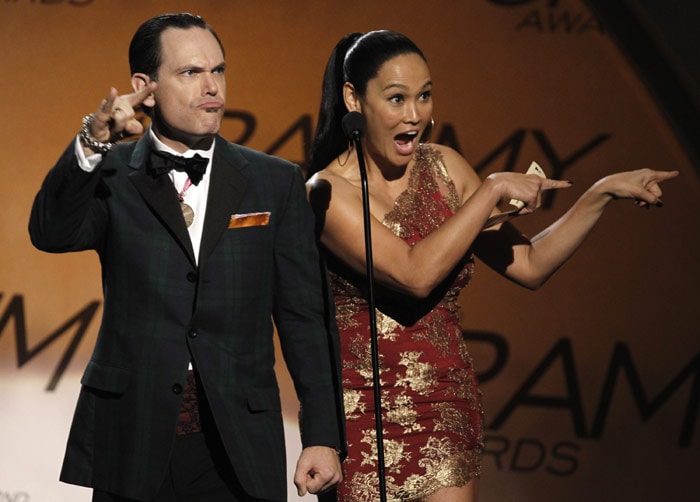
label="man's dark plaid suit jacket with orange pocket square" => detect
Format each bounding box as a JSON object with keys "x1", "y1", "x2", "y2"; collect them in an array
[{"x1": 30, "y1": 135, "x2": 344, "y2": 500}]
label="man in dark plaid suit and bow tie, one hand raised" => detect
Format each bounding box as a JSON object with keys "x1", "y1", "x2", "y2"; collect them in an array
[{"x1": 30, "y1": 14, "x2": 344, "y2": 502}]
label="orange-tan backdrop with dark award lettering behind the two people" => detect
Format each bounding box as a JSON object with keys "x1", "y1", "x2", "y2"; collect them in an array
[{"x1": 0, "y1": 0, "x2": 700, "y2": 502}]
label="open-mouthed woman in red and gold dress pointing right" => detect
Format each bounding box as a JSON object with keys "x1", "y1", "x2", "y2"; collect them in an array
[{"x1": 307, "y1": 31, "x2": 678, "y2": 502}]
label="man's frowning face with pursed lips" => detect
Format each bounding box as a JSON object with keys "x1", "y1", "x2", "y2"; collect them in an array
[{"x1": 152, "y1": 28, "x2": 226, "y2": 150}]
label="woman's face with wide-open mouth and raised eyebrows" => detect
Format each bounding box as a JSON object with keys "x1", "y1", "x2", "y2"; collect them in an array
[{"x1": 359, "y1": 54, "x2": 433, "y2": 166}]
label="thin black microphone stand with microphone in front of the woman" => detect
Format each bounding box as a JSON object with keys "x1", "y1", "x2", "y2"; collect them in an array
[{"x1": 351, "y1": 126, "x2": 386, "y2": 502}]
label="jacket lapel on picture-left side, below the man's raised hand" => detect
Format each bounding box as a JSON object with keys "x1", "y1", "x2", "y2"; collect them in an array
[{"x1": 129, "y1": 134, "x2": 196, "y2": 265}]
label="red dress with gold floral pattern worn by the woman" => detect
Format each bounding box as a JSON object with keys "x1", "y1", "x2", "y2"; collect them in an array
[{"x1": 329, "y1": 145, "x2": 483, "y2": 502}]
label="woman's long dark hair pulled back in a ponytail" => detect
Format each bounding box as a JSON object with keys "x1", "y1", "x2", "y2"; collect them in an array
[{"x1": 307, "y1": 30, "x2": 426, "y2": 177}]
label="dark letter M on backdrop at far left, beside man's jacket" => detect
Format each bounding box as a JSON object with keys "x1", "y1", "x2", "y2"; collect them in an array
[{"x1": 0, "y1": 294, "x2": 100, "y2": 391}]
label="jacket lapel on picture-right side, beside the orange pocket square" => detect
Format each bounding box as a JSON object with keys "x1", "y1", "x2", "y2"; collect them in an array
[{"x1": 199, "y1": 136, "x2": 248, "y2": 267}]
